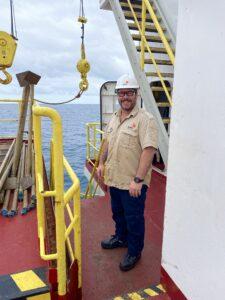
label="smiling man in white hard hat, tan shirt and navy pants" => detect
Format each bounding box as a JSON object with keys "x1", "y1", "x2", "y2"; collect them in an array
[{"x1": 97, "y1": 75, "x2": 158, "y2": 271}]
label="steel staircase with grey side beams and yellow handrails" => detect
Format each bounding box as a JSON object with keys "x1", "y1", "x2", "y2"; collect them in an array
[{"x1": 103, "y1": 0, "x2": 175, "y2": 166}]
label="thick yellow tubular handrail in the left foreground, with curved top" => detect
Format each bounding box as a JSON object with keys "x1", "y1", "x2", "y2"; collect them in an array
[{"x1": 33, "y1": 106, "x2": 81, "y2": 296}]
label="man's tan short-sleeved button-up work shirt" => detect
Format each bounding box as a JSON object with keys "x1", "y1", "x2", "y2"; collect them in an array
[{"x1": 104, "y1": 106, "x2": 158, "y2": 190}]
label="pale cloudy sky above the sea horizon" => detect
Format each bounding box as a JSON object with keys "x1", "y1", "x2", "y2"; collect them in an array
[{"x1": 0, "y1": 0, "x2": 131, "y2": 104}]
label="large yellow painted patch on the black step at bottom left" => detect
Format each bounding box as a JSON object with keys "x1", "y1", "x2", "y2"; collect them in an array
[{"x1": 11, "y1": 270, "x2": 46, "y2": 292}]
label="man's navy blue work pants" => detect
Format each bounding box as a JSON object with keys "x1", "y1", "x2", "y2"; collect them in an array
[{"x1": 110, "y1": 185, "x2": 148, "y2": 256}]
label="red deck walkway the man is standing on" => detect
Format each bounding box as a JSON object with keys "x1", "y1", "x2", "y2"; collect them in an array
[{"x1": 82, "y1": 172, "x2": 170, "y2": 300}]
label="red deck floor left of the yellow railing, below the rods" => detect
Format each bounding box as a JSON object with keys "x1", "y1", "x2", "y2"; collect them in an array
[{"x1": 0, "y1": 202, "x2": 47, "y2": 275}]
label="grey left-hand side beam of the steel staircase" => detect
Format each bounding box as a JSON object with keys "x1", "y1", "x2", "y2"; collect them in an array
[{"x1": 109, "y1": 0, "x2": 169, "y2": 167}]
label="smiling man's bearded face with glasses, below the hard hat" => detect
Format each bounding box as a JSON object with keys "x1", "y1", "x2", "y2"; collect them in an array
[{"x1": 117, "y1": 89, "x2": 137, "y2": 112}]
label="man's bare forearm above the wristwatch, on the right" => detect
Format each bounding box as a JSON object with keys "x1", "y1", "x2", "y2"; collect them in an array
[{"x1": 136, "y1": 147, "x2": 156, "y2": 179}]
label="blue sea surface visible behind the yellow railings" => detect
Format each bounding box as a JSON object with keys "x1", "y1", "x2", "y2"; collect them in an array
[{"x1": 0, "y1": 104, "x2": 100, "y2": 191}]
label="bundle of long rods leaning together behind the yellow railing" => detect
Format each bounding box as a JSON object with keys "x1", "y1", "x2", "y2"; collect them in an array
[{"x1": 0, "y1": 86, "x2": 36, "y2": 217}]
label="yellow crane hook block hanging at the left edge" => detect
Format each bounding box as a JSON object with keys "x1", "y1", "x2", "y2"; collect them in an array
[{"x1": 0, "y1": 31, "x2": 17, "y2": 84}]
